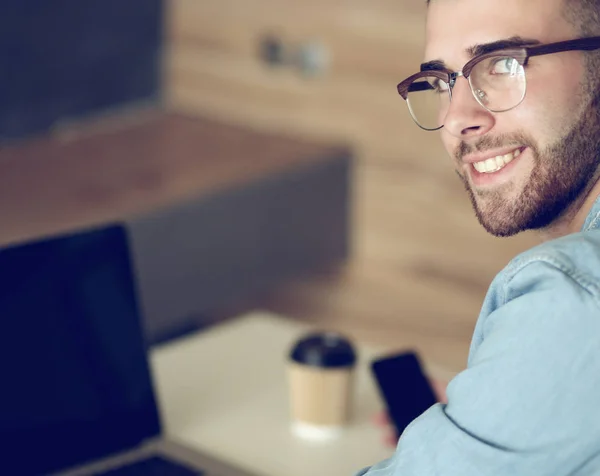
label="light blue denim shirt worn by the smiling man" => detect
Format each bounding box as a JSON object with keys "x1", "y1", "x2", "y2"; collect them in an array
[{"x1": 358, "y1": 195, "x2": 600, "y2": 476}]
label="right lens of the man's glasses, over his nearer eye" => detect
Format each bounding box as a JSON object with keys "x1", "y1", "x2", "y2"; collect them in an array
[{"x1": 469, "y1": 56, "x2": 527, "y2": 112}]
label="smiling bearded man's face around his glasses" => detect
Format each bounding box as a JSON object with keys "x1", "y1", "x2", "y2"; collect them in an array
[{"x1": 425, "y1": 0, "x2": 600, "y2": 236}]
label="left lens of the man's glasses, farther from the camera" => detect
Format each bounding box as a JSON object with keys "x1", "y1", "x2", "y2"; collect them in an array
[{"x1": 406, "y1": 76, "x2": 450, "y2": 130}]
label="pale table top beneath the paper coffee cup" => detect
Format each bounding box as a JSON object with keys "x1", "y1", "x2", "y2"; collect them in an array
[{"x1": 151, "y1": 312, "x2": 392, "y2": 476}]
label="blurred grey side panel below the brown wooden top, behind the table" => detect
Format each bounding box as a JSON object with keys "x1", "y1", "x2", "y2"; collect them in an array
[{"x1": 127, "y1": 151, "x2": 352, "y2": 342}]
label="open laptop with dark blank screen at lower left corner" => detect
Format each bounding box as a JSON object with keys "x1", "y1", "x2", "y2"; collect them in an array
[{"x1": 0, "y1": 225, "x2": 252, "y2": 476}]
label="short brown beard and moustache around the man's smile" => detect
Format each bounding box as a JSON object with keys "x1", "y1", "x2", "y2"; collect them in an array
[{"x1": 456, "y1": 88, "x2": 600, "y2": 237}]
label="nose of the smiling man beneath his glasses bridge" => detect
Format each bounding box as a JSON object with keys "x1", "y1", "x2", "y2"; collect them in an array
[{"x1": 444, "y1": 77, "x2": 495, "y2": 140}]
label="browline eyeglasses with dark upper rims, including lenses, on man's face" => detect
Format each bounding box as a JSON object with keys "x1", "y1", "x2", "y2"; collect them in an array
[{"x1": 398, "y1": 36, "x2": 600, "y2": 131}]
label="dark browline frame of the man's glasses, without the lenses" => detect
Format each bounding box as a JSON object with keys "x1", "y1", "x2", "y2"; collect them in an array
[{"x1": 396, "y1": 36, "x2": 600, "y2": 131}]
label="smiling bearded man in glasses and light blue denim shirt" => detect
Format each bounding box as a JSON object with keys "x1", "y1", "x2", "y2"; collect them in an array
[{"x1": 360, "y1": 0, "x2": 600, "y2": 476}]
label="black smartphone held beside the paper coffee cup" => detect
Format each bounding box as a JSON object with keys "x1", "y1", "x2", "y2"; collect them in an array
[{"x1": 371, "y1": 352, "x2": 438, "y2": 437}]
